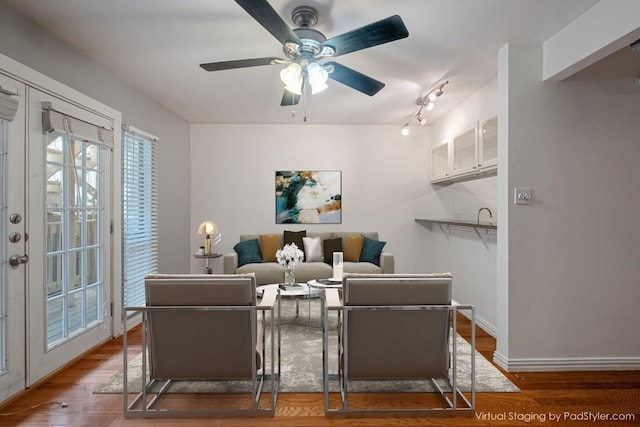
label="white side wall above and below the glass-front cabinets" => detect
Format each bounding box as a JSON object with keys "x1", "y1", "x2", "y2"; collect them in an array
[{"x1": 419, "y1": 80, "x2": 500, "y2": 336}]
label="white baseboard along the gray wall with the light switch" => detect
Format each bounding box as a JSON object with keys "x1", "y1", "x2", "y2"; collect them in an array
[{"x1": 493, "y1": 351, "x2": 640, "y2": 372}]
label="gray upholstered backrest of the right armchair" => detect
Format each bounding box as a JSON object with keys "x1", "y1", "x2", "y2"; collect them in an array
[{"x1": 343, "y1": 273, "x2": 452, "y2": 379}]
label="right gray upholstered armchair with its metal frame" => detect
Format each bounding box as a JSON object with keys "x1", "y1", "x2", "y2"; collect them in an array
[{"x1": 323, "y1": 273, "x2": 475, "y2": 415}]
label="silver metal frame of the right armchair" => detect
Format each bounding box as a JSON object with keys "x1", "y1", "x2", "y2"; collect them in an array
[{"x1": 322, "y1": 279, "x2": 476, "y2": 416}]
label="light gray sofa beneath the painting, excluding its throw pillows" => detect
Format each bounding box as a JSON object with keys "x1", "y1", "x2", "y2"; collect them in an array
[{"x1": 223, "y1": 231, "x2": 394, "y2": 285}]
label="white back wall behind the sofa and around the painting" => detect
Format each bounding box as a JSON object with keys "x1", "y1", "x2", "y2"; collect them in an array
[{"x1": 191, "y1": 124, "x2": 430, "y2": 272}]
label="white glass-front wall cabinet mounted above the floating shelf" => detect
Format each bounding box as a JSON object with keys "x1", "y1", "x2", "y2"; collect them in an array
[{"x1": 431, "y1": 117, "x2": 498, "y2": 184}]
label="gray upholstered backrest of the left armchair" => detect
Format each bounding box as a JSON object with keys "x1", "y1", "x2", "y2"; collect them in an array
[{"x1": 145, "y1": 274, "x2": 257, "y2": 380}]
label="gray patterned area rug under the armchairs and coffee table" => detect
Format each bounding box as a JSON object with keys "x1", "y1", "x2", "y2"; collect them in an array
[{"x1": 94, "y1": 300, "x2": 520, "y2": 393}]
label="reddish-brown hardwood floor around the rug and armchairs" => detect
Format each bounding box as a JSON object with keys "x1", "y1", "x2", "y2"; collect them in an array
[{"x1": 0, "y1": 317, "x2": 640, "y2": 427}]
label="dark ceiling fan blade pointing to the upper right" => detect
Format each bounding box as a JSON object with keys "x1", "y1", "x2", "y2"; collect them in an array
[{"x1": 323, "y1": 15, "x2": 409, "y2": 56}]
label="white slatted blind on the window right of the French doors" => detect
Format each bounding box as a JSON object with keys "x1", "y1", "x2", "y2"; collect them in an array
[{"x1": 122, "y1": 125, "x2": 158, "y2": 306}]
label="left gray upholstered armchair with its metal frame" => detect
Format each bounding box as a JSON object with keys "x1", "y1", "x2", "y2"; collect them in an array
[{"x1": 124, "y1": 274, "x2": 280, "y2": 417}]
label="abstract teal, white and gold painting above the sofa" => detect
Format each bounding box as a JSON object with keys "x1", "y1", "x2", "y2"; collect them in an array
[{"x1": 276, "y1": 171, "x2": 342, "y2": 224}]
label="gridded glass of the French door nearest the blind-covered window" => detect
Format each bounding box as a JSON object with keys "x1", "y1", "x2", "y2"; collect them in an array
[{"x1": 46, "y1": 134, "x2": 104, "y2": 348}]
